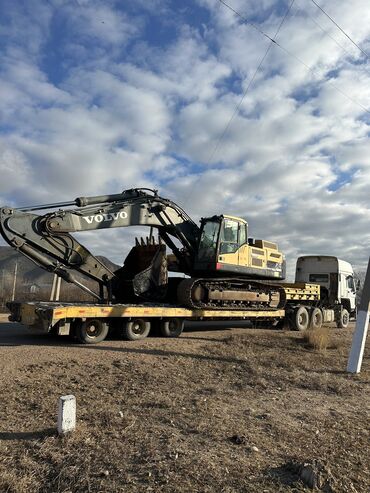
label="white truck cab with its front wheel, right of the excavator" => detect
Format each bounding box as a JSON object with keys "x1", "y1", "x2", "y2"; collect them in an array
[{"x1": 295, "y1": 255, "x2": 356, "y2": 327}]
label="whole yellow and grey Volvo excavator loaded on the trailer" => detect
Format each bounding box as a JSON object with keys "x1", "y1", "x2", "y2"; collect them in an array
[{"x1": 0, "y1": 188, "x2": 285, "y2": 310}]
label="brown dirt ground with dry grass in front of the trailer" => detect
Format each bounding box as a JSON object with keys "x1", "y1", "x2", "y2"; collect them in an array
[{"x1": 0, "y1": 318, "x2": 370, "y2": 493}]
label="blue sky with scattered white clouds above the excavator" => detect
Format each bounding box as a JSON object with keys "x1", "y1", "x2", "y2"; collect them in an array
[{"x1": 0, "y1": 0, "x2": 370, "y2": 272}]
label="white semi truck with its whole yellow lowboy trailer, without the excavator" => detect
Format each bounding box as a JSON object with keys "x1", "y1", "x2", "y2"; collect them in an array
[{"x1": 4, "y1": 255, "x2": 358, "y2": 344}]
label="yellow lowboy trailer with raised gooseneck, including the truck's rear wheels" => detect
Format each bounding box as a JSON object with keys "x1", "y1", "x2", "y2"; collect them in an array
[{"x1": 8, "y1": 283, "x2": 342, "y2": 344}]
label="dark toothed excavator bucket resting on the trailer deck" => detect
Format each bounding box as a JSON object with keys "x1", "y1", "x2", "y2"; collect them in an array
[{"x1": 115, "y1": 239, "x2": 168, "y2": 301}]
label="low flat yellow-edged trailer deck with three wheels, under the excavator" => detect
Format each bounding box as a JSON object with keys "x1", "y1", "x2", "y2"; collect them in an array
[{"x1": 8, "y1": 302, "x2": 285, "y2": 344}]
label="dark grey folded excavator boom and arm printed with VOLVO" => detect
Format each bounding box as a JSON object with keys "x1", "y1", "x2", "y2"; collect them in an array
[{"x1": 0, "y1": 188, "x2": 200, "y2": 301}]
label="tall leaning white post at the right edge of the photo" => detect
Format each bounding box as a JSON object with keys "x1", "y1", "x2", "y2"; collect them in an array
[{"x1": 347, "y1": 258, "x2": 370, "y2": 373}]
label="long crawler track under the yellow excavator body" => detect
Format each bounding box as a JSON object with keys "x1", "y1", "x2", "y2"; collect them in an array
[{"x1": 177, "y1": 278, "x2": 285, "y2": 310}]
